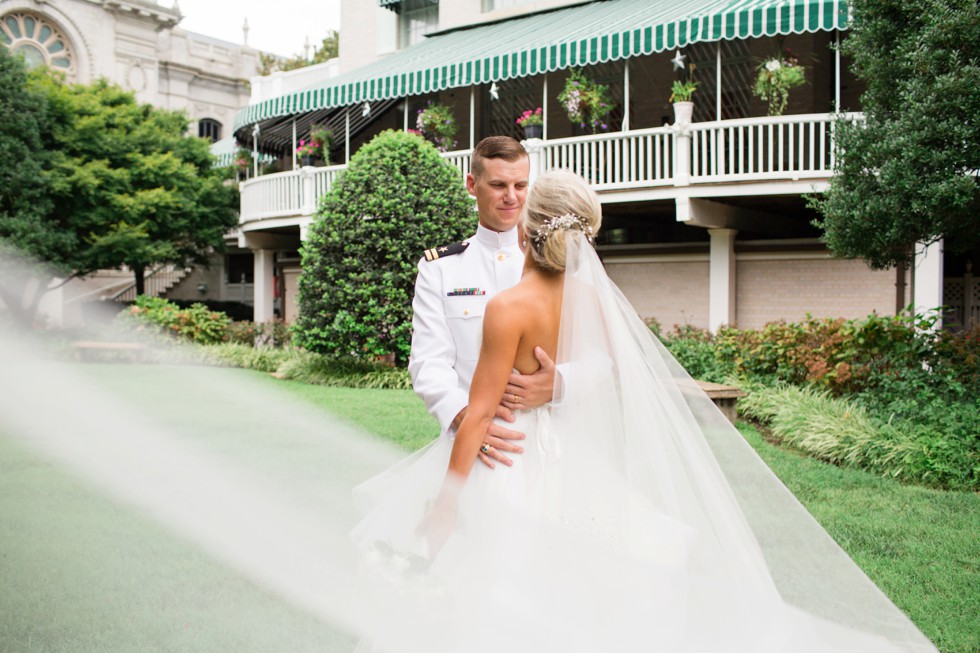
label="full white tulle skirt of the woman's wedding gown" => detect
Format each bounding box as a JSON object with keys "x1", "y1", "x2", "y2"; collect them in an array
[{"x1": 352, "y1": 408, "x2": 912, "y2": 653}]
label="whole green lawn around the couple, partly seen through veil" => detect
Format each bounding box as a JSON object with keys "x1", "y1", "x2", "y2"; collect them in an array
[{"x1": 0, "y1": 365, "x2": 980, "y2": 653}]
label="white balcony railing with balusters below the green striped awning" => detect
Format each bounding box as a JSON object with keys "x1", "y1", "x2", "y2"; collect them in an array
[{"x1": 240, "y1": 114, "x2": 848, "y2": 225}]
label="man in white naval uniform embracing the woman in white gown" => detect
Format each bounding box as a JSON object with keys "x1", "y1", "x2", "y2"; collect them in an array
[{"x1": 408, "y1": 136, "x2": 555, "y2": 468}]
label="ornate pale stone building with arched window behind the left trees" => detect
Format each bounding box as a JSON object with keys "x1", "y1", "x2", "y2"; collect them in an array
[{"x1": 0, "y1": 0, "x2": 260, "y2": 325}]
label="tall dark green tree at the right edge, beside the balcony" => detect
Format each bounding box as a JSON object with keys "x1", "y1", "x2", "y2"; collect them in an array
[{"x1": 812, "y1": 0, "x2": 980, "y2": 269}]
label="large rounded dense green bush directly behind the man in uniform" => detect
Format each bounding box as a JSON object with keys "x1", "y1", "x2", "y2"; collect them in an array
[{"x1": 294, "y1": 130, "x2": 476, "y2": 364}]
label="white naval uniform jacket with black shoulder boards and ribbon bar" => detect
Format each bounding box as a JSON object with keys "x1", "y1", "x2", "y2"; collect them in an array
[{"x1": 408, "y1": 226, "x2": 524, "y2": 434}]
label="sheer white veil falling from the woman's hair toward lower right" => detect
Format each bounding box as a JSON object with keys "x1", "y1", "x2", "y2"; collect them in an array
[{"x1": 551, "y1": 233, "x2": 935, "y2": 651}]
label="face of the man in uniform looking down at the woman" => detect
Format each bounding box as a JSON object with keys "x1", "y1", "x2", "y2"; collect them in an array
[{"x1": 466, "y1": 156, "x2": 531, "y2": 231}]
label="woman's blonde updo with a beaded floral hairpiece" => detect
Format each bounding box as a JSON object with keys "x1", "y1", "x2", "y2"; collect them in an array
[{"x1": 523, "y1": 170, "x2": 602, "y2": 272}]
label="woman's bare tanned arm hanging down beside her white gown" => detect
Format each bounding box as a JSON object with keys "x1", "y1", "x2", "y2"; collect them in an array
[{"x1": 448, "y1": 296, "x2": 522, "y2": 482}]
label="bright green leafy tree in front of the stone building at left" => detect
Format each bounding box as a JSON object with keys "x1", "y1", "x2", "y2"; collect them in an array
[{"x1": 32, "y1": 74, "x2": 237, "y2": 293}]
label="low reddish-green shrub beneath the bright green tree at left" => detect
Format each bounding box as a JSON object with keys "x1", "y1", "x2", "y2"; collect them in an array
[{"x1": 117, "y1": 295, "x2": 231, "y2": 344}]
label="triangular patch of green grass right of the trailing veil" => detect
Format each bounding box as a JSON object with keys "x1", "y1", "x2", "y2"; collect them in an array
[{"x1": 739, "y1": 423, "x2": 980, "y2": 653}]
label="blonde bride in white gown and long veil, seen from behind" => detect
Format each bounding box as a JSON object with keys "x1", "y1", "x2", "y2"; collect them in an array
[{"x1": 352, "y1": 172, "x2": 935, "y2": 653}]
